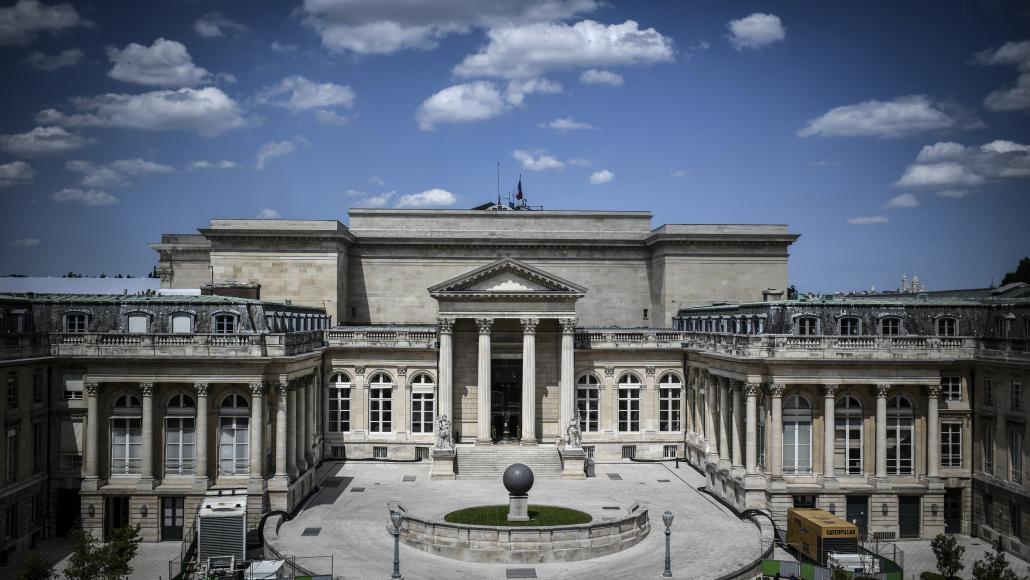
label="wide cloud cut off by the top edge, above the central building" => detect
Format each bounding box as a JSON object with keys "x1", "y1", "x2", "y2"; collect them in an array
[{"x1": 301, "y1": 0, "x2": 599, "y2": 55}]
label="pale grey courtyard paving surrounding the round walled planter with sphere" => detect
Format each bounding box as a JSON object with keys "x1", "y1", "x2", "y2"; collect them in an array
[{"x1": 275, "y1": 463, "x2": 767, "y2": 580}]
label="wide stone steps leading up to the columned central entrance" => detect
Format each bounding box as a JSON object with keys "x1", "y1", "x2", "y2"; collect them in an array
[{"x1": 455, "y1": 444, "x2": 561, "y2": 481}]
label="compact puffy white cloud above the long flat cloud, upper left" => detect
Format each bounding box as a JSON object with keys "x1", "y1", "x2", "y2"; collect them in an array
[{"x1": 107, "y1": 38, "x2": 212, "y2": 87}]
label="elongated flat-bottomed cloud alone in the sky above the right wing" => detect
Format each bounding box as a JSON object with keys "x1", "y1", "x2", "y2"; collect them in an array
[{"x1": 797, "y1": 95, "x2": 956, "y2": 138}]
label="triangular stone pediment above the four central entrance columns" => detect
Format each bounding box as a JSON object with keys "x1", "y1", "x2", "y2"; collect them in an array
[{"x1": 428, "y1": 258, "x2": 586, "y2": 298}]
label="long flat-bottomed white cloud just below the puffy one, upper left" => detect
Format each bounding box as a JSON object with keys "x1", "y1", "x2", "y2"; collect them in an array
[{"x1": 36, "y1": 87, "x2": 247, "y2": 137}]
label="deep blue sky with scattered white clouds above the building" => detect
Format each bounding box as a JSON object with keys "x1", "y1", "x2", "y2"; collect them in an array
[{"x1": 0, "y1": 0, "x2": 1030, "y2": 292}]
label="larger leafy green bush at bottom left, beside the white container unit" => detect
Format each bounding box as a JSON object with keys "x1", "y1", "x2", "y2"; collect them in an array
[{"x1": 65, "y1": 527, "x2": 140, "y2": 580}]
